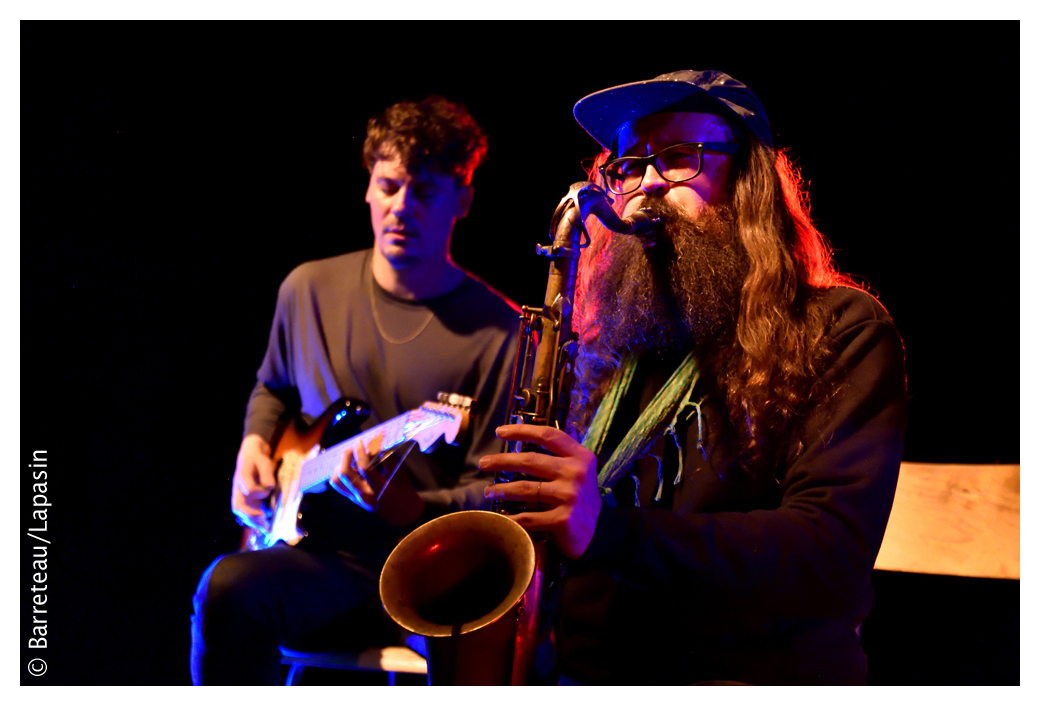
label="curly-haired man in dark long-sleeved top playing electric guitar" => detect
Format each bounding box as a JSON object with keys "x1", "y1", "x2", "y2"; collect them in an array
[{"x1": 191, "y1": 97, "x2": 518, "y2": 684}]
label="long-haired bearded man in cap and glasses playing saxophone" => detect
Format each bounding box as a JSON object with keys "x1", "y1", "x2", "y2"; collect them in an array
[{"x1": 479, "y1": 71, "x2": 906, "y2": 684}]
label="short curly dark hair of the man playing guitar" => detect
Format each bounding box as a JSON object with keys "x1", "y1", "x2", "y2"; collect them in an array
[{"x1": 361, "y1": 96, "x2": 488, "y2": 185}]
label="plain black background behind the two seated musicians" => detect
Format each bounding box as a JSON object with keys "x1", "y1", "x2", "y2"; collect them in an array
[{"x1": 20, "y1": 22, "x2": 1019, "y2": 684}]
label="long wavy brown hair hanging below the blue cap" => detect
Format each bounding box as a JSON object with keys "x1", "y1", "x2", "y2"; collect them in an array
[{"x1": 571, "y1": 137, "x2": 858, "y2": 470}]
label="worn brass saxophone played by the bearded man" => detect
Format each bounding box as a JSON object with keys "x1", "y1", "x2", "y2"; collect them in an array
[{"x1": 380, "y1": 182, "x2": 659, "y2": 685}]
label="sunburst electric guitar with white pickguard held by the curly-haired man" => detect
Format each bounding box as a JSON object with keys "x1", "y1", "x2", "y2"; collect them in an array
[{"x1": 241, "y1": 393, "x2": 473, "y2": 550}]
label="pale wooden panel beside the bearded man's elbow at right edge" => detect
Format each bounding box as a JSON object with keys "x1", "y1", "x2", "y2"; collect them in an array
[{"x1": 875, "y1": 462, "x2": 1019, "y2": 579}]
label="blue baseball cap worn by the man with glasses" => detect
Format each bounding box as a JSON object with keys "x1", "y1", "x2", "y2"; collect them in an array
[{"x1": 574, "y1": 70, "x2": 773, "y2": 152}]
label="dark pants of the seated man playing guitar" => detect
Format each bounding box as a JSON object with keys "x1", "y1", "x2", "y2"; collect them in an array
[{"x1": 191, "y1": 541, "x2": 399, "y2": 685}]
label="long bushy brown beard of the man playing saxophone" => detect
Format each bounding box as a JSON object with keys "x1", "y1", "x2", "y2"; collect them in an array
[{"x1": 570, "y1": 198, "x2": 748, "y2": 435}]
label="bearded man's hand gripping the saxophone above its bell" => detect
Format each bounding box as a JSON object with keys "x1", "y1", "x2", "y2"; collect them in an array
[{"x1": 479, "y1": 424, "x2": 603, "y2": 559}]
